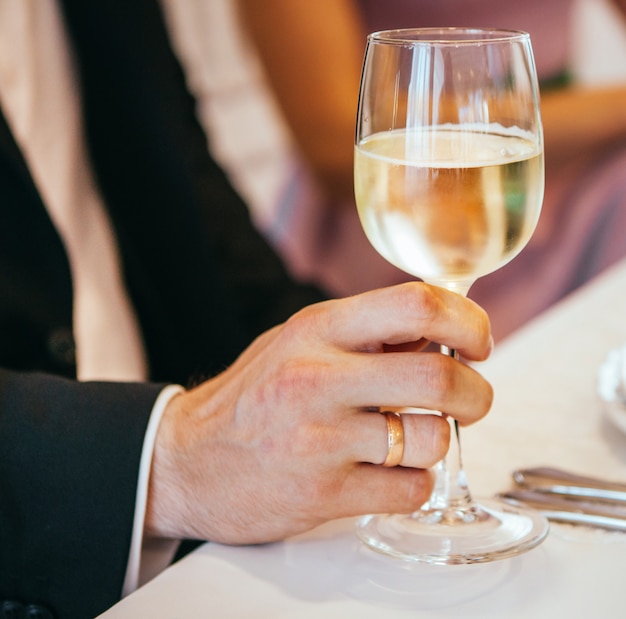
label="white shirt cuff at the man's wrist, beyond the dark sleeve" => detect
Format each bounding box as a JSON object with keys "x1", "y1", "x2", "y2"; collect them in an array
[{"x1": 122, "y1": 385, "x2": 184, "y2": 597}]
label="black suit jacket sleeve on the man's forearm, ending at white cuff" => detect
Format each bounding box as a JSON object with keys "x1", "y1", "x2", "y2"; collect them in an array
[{"x1": 0, "y1": 369, "x2": 163, "y2": 619}]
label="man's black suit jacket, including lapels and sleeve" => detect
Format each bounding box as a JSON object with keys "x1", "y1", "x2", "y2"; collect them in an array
[{"x1": 0, "y1": 0, "x2": 322, "y2": 619}]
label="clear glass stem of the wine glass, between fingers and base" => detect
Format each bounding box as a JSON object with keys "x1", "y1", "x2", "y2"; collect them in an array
[{"x1": 428, "y1": 346, "x2": 472, "y2": 511}]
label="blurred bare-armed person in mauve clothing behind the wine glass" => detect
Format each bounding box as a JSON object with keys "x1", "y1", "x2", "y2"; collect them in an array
[{"x1": 239, "y1": 0, "x2": 626, "y2": 339}]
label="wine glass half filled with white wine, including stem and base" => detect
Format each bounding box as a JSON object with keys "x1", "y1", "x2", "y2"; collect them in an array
[{"x1": 354, "y1": 28, "x2": 548, "y2": 564}]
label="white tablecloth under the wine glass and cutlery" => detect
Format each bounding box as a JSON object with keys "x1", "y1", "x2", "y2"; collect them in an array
[{"x1": 102, "y1": 262, "x2": 626, "y2": 619}]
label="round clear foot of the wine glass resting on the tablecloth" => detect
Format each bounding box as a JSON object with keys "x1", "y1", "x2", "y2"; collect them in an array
[{"x1": 356, "y1": 500, "x2": 549, "y2": 565}]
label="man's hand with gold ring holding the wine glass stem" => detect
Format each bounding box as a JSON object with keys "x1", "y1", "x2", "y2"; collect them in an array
[{"x1": 146, "y1": 283, "x2": 492, "y2": 543}]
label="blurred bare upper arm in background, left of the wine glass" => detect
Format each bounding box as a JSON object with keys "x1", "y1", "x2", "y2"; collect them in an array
[{"x1": 239, "y1": 0, "x2": 365, "y2": 200}]
